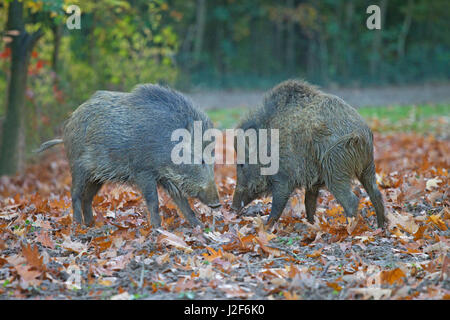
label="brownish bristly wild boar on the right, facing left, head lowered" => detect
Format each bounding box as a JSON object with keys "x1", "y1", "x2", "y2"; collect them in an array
[{"x1": 232, "y1": 80, "x2": 384, "y2": 227}]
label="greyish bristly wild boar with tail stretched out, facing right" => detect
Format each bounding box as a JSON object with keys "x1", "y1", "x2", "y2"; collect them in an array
[{"x1": 36, "y1": 84, "x2": 220, "y2": 227}]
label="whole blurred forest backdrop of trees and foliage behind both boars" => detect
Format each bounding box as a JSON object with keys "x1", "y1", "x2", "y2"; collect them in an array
[{"x1": 0, "y1": 0, "x2": 450, "y2": 174}]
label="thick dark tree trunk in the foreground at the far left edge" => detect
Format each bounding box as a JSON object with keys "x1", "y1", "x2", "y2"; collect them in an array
[{"x1": 0, "y1": 0, "x2": 42, "y2": 175}]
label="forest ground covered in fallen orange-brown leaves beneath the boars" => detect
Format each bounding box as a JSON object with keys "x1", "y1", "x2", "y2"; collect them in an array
[{"x1": 0, "y1": 107, "x2": 450, "y2": 300}]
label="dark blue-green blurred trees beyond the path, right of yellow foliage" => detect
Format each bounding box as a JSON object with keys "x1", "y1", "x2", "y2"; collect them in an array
[{"x1": 176, "y1": 0, "x2": 450, "y2": 89}]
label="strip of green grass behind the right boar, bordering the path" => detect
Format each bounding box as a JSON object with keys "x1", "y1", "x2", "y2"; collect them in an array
[{"x1": 207, "y1": 104, "x2": 450, "y2": 135}]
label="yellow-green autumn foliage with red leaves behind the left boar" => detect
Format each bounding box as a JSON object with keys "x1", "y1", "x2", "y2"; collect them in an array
[{"x1": 0, "y1": 0, "x2": 179, "y2": 155}]
